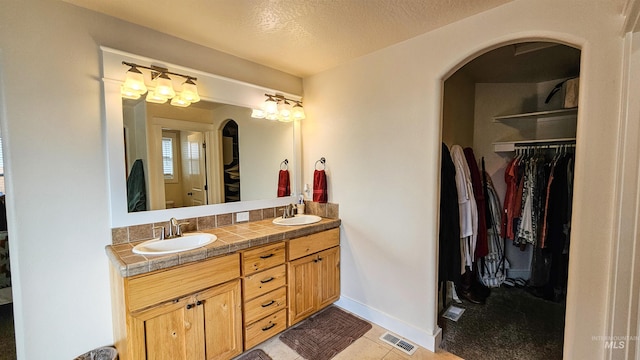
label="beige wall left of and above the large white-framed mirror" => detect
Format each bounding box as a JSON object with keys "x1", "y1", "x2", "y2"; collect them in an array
[{"x1": 0, "y1": 0, "x2": 302, "y2": 359}]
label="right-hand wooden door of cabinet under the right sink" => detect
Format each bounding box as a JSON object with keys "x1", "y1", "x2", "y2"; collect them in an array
[{"x1": 316, "y1": 246, "x2": 340, "y2": 310}]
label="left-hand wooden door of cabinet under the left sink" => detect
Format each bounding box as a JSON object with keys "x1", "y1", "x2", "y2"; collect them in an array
[{"x1": 132, "y1": 296, "x2": 204, "y2": 360}]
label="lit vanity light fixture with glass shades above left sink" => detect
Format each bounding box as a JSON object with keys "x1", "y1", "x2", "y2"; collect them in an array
[{"x1": 120, "y1": 61, "x2": 200, "y2": 107}]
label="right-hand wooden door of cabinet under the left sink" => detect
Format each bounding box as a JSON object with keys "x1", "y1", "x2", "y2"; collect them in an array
[{"x1": 200, "y1": 279, "x2": 242, "y2": 360}]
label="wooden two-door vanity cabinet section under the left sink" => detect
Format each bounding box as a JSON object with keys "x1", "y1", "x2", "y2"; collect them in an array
[{"x1": 112, "y1": 254, "x2": 243, "y2": 360}]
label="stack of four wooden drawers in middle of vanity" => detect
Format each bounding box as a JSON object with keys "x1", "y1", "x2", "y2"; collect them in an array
[{"x1": 242, "y1": 242, "x2": 287, "y2": 349}]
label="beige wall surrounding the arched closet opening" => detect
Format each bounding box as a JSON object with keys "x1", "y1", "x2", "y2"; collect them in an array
[{"x1": 303, "y1": 0, "x2": 622, "y2": 359}]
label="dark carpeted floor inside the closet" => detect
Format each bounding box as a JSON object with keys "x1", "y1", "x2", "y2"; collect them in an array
[{"x1": 440, "y1": 287, "x2": 565, "y2": 360}]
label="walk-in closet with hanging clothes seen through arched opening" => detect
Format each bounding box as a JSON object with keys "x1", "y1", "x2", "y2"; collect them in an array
[{"x1": 439, "y1": 42, "x2": 580, "y2": 360}]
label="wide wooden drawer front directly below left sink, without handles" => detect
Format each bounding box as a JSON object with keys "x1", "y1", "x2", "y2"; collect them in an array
[{"x1": 125, "y1": 254, "x2": 240, "y2": 311}]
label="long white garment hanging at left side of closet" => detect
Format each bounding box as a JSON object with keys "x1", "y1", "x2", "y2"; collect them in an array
[{"x1": 451, "y1": 145, "x2": 478, "y2": 272}]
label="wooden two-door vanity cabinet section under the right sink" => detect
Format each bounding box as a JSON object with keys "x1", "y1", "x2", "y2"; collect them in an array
[{"x1": 287, "y1": 228, "x2": 340, "y2": 326}]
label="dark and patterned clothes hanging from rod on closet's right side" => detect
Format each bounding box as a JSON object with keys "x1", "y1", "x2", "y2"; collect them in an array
[{"x1": 502, "y1": 147, "x2": 573, "y2": 301}]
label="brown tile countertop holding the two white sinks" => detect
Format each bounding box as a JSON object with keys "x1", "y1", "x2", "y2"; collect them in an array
[{"x1": 105, "y1": 218, "x2": 341, "y2": 277}]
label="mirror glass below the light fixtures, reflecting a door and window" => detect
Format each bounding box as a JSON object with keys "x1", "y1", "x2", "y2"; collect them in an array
[{"x1": 122, "y1": 98, "x2": 293, "y2": 212}]
